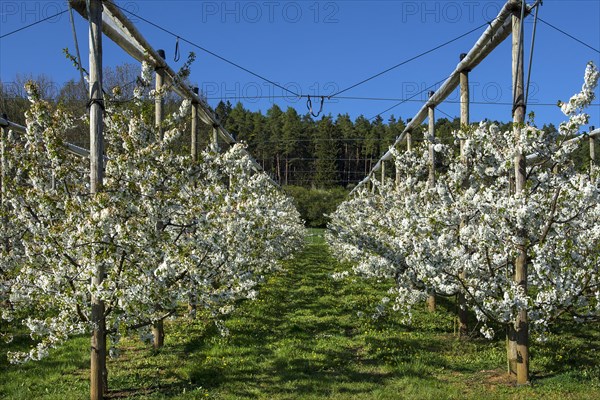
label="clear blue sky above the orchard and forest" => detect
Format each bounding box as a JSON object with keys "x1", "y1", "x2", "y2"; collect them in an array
[{"x1": 0, "y1": 0, "x2": 600, "y2": 126}]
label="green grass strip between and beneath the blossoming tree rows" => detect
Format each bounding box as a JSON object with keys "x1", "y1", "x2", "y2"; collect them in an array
[{"x1": 0, "y1": 231, "x2": 600, "y2": 400}]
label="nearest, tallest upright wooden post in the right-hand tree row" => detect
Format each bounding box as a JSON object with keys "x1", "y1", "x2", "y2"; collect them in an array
[{"x1": 509, "y1": 7, "x2": 529, "y2": 385}]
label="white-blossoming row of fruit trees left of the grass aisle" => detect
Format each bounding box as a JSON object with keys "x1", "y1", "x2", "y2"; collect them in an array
[{"x1": 0, "y1": 66, "x2": 304, "y2": 396}]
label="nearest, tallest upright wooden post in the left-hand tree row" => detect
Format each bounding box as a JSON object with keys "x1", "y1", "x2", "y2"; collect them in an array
[{"x1": 87, "y1": 0, "x2": 107, "y2": 400}]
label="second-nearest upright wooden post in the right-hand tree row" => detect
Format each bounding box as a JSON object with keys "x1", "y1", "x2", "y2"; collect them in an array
[{"x1": 456, "y1": 53, "x2": 470, "y2": 337}]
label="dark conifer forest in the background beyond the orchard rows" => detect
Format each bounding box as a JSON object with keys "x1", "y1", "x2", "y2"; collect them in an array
[{"x1": 0, "y1": 64, "x2": 587, "y2": 189}]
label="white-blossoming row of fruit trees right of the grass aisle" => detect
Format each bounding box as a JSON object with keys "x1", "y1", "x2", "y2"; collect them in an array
[{"x1": 326, "y1": 63, "x2": 600, "y2": 382}]
